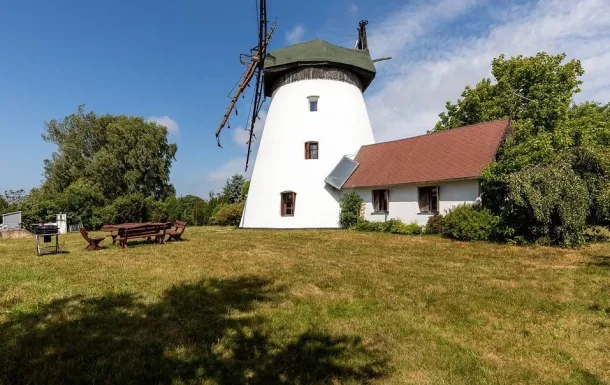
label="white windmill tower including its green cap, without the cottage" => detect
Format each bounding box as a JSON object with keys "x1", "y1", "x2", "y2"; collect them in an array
[{"x1": 219, "y1": 8, "x2": 376, "y2": 228}]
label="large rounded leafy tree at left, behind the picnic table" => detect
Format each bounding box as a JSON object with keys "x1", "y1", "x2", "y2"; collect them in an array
[{"x1": 43, "y1": 106, "x2": 177, "y2": 200}]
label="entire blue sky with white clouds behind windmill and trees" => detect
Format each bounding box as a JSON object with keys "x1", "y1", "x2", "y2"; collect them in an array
[{"x1": 0, "y1": 0, "x2": 610, "y2": 196}]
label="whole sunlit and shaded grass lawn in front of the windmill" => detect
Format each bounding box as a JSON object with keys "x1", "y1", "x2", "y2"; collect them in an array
[{"x1": 0, "y1": 228, "x2": 610, "y2": 385}]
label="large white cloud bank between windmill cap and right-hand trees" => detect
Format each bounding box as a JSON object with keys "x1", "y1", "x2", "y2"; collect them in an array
[{"x1": 367, "y1": 0, "x2": 610, "y2": 141}]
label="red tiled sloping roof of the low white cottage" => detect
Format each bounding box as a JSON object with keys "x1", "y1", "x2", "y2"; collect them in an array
[{"x1": 343, "y1": 120, "x2": 510, "y2": 188}]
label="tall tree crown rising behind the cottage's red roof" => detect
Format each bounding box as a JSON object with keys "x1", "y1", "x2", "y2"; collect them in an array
[{"x1": 434, "y1": 52, "x2": 584, "y2": 134}]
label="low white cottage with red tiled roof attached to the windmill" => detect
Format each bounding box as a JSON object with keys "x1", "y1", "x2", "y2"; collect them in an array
[{"x1": 341, "y1": 120, "x2": 510, "y2": 225}]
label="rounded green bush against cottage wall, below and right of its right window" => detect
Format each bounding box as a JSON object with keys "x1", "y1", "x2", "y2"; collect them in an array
[{"x1": 443, "y1": 205, "x2": 498, "y2": 241}]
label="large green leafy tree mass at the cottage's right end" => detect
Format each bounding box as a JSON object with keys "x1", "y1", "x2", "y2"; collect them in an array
[{"x1": 434, "y1": 53, "x2": 610, "y2": 245}]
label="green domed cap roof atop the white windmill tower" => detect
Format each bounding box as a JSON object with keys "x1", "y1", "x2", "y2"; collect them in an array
[{"x1": 265, "y1": 39, "x2": 376, "y2": 96}]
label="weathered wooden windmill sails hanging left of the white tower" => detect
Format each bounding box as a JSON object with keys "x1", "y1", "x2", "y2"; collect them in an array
[{"x1": 216, "y1": 0, "x2": 277, "y2": 171}]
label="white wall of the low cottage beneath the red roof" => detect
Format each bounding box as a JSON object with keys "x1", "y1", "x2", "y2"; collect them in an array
[{"x1": 354, "y1": 180, "x2": 479, "y2": 226}]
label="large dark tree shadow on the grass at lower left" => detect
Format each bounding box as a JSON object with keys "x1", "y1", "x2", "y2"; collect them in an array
[{"x1": 0, "y1": 277, "x2": 388, "y2": 385}]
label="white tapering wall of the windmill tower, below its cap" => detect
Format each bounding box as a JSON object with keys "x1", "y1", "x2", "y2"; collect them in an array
[{"x1": 241, "y1": 80, "x2": 374, "y2": 228}]
